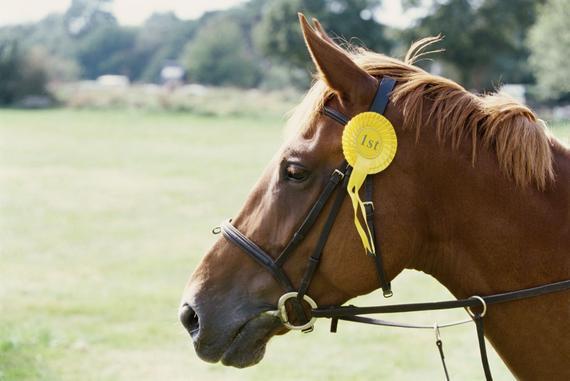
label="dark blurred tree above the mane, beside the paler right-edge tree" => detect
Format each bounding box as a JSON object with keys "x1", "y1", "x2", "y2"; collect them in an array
[{"x1": 405, "y1": 0, "x2": 539, "y2": 91}]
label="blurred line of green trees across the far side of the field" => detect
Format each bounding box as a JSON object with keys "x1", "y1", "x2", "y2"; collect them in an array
[{"x1": 0, "y1": 0, "x2": 570, "y2": 103}]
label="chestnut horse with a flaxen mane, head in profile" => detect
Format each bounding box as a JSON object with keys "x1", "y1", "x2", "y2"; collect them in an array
[{"x1": 179, "y1": 14, "x2": 570, "y2": 380}]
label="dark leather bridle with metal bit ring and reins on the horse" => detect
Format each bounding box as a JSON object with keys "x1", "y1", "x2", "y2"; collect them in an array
[{"x1": 213, "y1": 76, "x2": 570, "y2": 380}]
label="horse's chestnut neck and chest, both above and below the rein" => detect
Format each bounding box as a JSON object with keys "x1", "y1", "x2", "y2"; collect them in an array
[{"x1": 400, "y1": 132, "x2": 570, "y2": 380}]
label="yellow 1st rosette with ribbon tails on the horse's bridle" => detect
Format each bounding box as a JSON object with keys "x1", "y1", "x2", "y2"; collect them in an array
[{"x1": 342, "y1": 112, "x2": 398, "y2": 254}]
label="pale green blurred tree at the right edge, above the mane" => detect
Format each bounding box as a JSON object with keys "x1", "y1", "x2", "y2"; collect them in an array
[{"x1": 529, "y1": 0, "x2": 570, "y2": 99}]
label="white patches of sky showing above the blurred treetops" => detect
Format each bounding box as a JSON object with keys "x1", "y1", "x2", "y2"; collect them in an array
[{"x1": 0, "y1": 0, "x2": 412, "y2": 27}]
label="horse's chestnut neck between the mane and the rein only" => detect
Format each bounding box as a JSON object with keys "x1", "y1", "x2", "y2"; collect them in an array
[{"x1": 404, "y1": 132, "x2": 570, "y2": 297}]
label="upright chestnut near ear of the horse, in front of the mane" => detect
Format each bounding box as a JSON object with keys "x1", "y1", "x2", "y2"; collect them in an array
[{"x1": 299, "y1": 13, "x2": 378, "y2": 103}]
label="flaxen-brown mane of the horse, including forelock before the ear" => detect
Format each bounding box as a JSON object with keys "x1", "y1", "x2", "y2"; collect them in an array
[{"x1": 288, "y1": 37, "x2": 554, "y2": 190}]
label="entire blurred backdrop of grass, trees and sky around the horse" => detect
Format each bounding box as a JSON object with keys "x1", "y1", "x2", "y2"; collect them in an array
[{"x1": 0, "y1": 0, "x2": 570, "y2": 381}]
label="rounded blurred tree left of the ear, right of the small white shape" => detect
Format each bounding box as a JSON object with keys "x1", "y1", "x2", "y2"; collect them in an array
[{"x1": 184, "y1": 17, "x2": 261, "y2": 87}]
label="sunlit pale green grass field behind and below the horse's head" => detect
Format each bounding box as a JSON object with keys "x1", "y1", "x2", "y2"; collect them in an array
[{"x1": 0, "y1": 110, "x2": 570, "y2": 381}]
